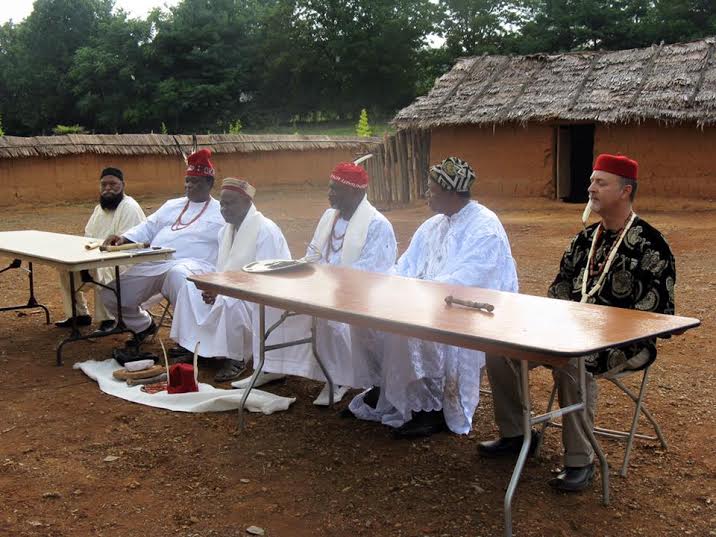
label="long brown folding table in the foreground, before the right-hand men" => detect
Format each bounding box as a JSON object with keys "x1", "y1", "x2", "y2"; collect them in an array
[{"x1": 189, "y1": 265, "x2": 700, "y2": 537}]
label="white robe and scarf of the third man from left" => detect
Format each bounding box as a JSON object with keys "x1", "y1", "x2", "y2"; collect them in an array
[{"x1": 171, "y1": 205, "x2": 291, "y2": 360}]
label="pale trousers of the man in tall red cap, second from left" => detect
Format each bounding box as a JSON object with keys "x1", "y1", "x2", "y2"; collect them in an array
[{"x1": 100, "y1": 259, "x2": 213, "y2": 332}]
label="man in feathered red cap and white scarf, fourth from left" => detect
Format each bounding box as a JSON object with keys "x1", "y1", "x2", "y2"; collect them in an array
[{"x1": 234, "y1": 162, "x2": 397, "y2": 406}]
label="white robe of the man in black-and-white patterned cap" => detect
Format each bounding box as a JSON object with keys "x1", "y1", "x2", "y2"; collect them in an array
[{"x1": 350, "y1": 201, "x2": 518, "y2": 434}]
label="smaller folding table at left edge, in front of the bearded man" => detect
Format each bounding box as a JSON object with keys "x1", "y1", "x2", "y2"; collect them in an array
[{"x1": 0, "y1": 230, "x2": 174, "y2": 366}]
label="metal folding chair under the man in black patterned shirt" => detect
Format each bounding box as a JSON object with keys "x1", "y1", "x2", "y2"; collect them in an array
[{"x1": 537, "y1": 366, "x2": 669, "y2": 477}]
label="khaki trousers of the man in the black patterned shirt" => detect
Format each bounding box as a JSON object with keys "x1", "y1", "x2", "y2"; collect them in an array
[{"x1": 486, "y1": 355, "x2": 598, "y2": 466}]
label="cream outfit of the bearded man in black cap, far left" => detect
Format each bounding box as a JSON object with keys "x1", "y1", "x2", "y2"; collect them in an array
[{"x1": 60, "y1": 194, "x2": 146, "y2": 321}]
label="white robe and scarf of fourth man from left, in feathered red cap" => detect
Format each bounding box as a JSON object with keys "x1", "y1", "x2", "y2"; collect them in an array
[{"x1": 262, "y1": 198, "x2": 397, "y2": 388}]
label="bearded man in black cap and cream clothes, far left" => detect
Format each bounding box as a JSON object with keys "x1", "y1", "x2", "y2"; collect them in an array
[{"x1": 55, "y1": 168, "x2": 146, "y2": 331}]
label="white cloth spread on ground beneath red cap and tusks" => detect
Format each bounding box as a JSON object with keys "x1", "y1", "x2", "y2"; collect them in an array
[{"x1": 73, "y1": 360, "x2": 296, "y2": 414}]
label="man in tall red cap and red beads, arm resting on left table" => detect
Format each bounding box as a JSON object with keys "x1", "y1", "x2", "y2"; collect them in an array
[{"x1": 102, "y1": 149, "x2": 224, "y2": 342}]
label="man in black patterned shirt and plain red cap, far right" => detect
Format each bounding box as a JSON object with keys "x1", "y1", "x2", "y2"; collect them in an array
[{"x1": 480, "y1": 154, "x2": 676, "y2": 491}]
